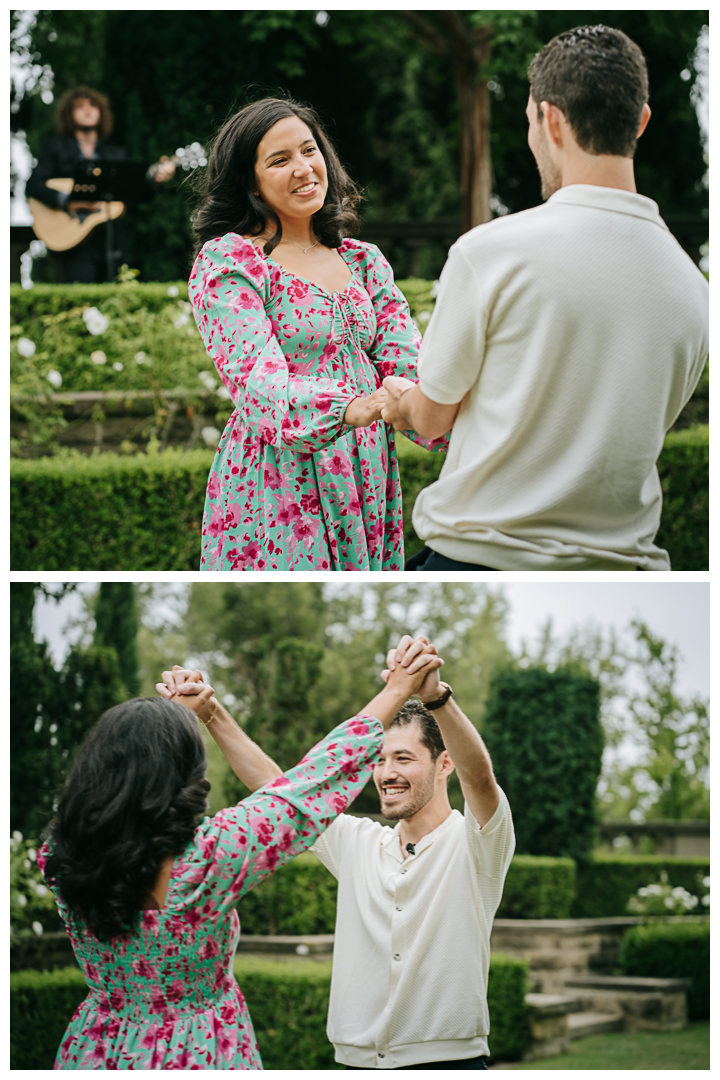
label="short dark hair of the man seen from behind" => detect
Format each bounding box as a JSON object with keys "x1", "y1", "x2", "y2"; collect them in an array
[{"x1": 528, "y1": 26, "x2": 648, "y2": 158}]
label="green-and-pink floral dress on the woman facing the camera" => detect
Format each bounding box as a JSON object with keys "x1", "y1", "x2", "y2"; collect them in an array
[{"x1": 189, "y1": 232, "x2": 447, "y2": 570}]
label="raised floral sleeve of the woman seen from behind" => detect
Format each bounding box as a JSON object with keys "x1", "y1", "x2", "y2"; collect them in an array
[{"x1": 173, "y1": 715, "x2": 383, "y2": 913}]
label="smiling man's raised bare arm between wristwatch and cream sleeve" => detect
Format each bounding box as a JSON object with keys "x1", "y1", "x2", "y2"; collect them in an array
[{"x1": 425, "y1": 698, "x2": 500, "y2": 825}]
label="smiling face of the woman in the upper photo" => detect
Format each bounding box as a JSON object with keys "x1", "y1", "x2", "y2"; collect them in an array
[{"x1": 255, "y1": 117, "x2": 327, "y2": 221}]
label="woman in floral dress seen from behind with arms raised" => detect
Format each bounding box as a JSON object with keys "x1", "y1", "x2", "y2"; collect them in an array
[{"x1": 38, "y1": 638, "x2": 443, "y2": 1069}]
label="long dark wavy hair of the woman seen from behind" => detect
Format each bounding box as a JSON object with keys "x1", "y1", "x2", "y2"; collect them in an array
[{"x1": 45, "y1": 698, "x2": 210, "y2": 939}]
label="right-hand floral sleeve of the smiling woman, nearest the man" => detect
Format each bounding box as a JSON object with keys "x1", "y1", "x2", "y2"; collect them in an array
[{"x1": 363, "y1": 244, "x2": 448, "y2": 451}]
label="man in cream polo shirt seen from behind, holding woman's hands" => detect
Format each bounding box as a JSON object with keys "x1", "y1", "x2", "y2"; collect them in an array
[{"x1": 383, "y1": 26, "x2": 708, "y2": 571}]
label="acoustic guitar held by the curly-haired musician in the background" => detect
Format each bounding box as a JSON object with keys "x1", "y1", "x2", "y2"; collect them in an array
[{"x1": 28, "y1": 143, "x2": 207, "y2": 252}]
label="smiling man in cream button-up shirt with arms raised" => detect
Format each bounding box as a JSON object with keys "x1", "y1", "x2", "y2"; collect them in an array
[{"x1": 312, "y1": 637, "x2": 515, "y2": 1069}]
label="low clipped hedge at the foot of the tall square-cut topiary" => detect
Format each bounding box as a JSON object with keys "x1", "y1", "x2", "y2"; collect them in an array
[{"x1": 497, "y1": 855, "x2": 575, "y2": 919}]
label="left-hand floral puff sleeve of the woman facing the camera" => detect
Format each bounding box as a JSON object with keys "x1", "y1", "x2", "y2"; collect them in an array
[{"x1": 188, "y1": 232, "x2": 357, "y2": 453}]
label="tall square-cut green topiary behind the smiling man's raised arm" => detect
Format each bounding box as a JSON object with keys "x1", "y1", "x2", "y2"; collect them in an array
[{"x1": 483, "y1": 666, "x2": 603, "y2": 859}]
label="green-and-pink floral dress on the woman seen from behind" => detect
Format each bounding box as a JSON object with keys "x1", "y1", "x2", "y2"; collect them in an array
[{"x1": 38, "y1": 716, "x2": 382, "y2": 1069}]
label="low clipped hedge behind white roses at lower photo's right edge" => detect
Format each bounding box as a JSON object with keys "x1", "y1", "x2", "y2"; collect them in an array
[{"x1": 572, "y1": 855, "x2": 710, "y2": 919}]
